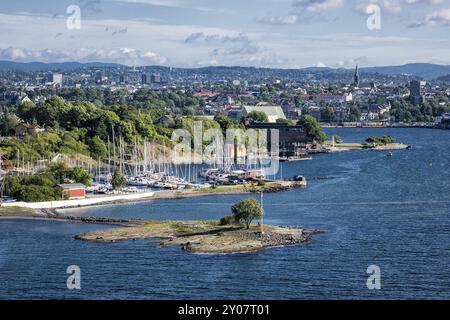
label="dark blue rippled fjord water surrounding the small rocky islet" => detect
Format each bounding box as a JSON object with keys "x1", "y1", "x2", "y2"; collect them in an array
[{"x1": 0, "y1": 129, "x2": 450, "y2": 299}]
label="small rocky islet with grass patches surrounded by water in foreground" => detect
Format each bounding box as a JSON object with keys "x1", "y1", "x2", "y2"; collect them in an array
[{"x1": 75, "y1": 221, "x2": 320, "y2": 254}]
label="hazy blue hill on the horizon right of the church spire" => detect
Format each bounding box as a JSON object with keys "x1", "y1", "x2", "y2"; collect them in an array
[{"x1": 361, "y1": 63, "x2": 450, "y2": 80}]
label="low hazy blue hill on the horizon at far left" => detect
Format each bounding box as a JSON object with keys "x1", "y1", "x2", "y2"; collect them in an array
[{"x1": 0, "y1": 61, "x2": 126, "y2": 72}]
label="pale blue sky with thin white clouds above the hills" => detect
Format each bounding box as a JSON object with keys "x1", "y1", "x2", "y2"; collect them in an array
[{"x1": 0, "y1": 0, "x2": 450, "y2": 68}]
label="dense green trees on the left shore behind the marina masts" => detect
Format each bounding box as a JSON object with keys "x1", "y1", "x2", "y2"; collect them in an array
[{"x1": 0, "y1": 89, "x2": 220, "y2": 161}]
